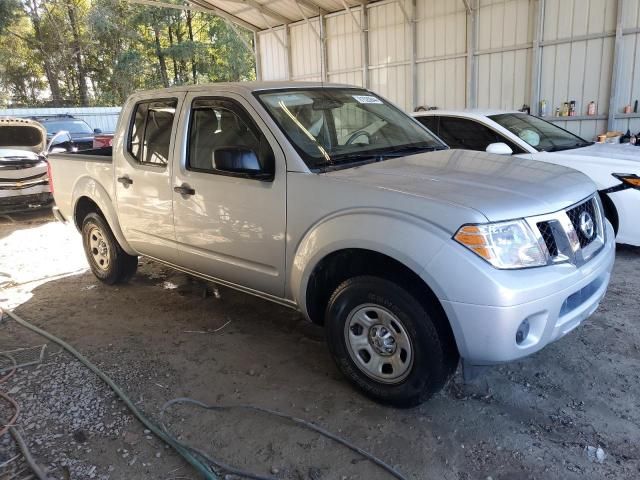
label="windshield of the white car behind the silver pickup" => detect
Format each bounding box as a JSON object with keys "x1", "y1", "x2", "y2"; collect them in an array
[{"x1": 489, "y1": 113, "x2": 591, "y2": 152}]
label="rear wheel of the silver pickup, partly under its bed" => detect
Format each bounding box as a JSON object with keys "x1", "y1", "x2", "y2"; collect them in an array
[{"x1": 82, "y1": 212, "x2": 138, "y2": 285}]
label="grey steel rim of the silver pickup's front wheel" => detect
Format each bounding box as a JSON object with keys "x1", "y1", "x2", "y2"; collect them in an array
[{"x1": 344, "y1": 304, "x2": 413, "y2": 384}]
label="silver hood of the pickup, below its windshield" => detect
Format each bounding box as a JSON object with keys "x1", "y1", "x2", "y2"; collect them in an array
[{"x1": 326, "y1": 150, "x2": 595, "y2": 221}]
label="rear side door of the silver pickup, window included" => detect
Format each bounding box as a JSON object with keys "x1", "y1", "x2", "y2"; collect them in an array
[{"x1": 114, "y1": 93, "x2": 183, "y2": 262}]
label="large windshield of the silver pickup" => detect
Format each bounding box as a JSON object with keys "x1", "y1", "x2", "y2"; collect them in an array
[{"x1": 257, "y1": 88, "x2": 447, "y2": 169}]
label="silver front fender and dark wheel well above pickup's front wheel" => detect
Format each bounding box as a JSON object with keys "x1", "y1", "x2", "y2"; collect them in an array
[{"x1": 290, "y1": 210, "x2": 453, "y2": 348}]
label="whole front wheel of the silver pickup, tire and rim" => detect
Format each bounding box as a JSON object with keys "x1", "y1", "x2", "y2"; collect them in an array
[{"x1": 325, "y1": 276, "x2": 458, "y2": 408}]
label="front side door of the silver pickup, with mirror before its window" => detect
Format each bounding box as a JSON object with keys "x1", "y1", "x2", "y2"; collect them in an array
[{"x1": 173, "y1": 93, "x2": 286, "y2": 296}]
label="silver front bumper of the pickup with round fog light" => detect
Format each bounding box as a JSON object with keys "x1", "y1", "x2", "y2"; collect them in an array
[{"x1": 440, "y1": 222, "x2": 615, "y2": 365}]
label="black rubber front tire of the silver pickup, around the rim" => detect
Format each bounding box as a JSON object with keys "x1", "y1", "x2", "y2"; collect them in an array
[{"x1": 325, "y1": 276, "x2": 459, "y2": 408}]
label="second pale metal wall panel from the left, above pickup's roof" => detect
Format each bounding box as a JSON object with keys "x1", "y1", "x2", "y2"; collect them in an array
[{"x1": 289, "y1": 18, "x2": 322, "y2": 80}]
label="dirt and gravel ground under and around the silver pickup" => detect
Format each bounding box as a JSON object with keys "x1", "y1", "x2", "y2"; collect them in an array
[{"x1": 0, "y1": 216, "x2": 640, "y2": 480}]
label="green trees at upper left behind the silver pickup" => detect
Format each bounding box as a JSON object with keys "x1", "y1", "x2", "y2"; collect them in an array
[{"x1": 0, "y1": 0, "x2": 255, "y2": 107}]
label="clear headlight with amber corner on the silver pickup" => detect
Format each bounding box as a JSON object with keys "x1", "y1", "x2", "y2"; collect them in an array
[{"x1": 453, "y1": 220, "x2": 548, "y2": 269}]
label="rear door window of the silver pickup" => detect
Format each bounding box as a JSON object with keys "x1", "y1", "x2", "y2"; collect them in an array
[{"x1": 127, "y1": 99, "x2": 178, "y2": 167}]
